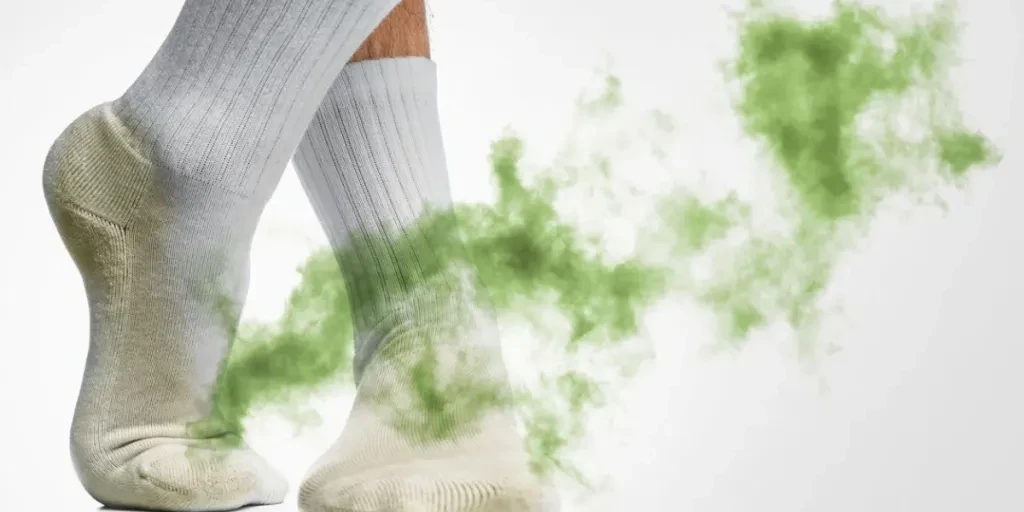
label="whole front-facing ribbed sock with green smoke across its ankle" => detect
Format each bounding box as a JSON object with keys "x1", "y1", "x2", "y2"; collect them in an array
[{"x1": 294, "y1": 57, "x2": 555, "y2": 512}]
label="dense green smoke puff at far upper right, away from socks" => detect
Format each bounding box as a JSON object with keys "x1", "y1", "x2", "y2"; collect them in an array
[{"x1": 697, "y1": 1, "x2": 995, "y2": 352}]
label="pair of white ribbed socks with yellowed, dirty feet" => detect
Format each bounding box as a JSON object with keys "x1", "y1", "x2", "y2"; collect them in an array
[{"x1": 43, "y1": 0, "x2": 553, "y2": 512}]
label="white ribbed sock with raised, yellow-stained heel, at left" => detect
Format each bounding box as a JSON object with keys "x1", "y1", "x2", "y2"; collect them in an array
[{"x1": 43, "y1": 0, "x2": 397, "y2": 510}]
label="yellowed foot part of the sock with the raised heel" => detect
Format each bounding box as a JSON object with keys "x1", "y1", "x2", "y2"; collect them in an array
[{"x1": 44, "y1": 103, "x2": 287, "y2": 510}]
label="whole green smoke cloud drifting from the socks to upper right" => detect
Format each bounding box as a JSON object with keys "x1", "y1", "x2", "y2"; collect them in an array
[{"x1": 188, "y1": 2, "x2": 997, "y2": 482}]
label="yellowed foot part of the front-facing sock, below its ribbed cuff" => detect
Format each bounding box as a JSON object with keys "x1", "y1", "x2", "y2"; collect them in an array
[{"x1": 299, "y1": 299, "x2": 556, "y2": 512}]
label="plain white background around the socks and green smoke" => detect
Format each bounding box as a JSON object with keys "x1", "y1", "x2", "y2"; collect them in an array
[{"x1": 0, "y1": 0, "x2": 1024, "y2": 512}]
